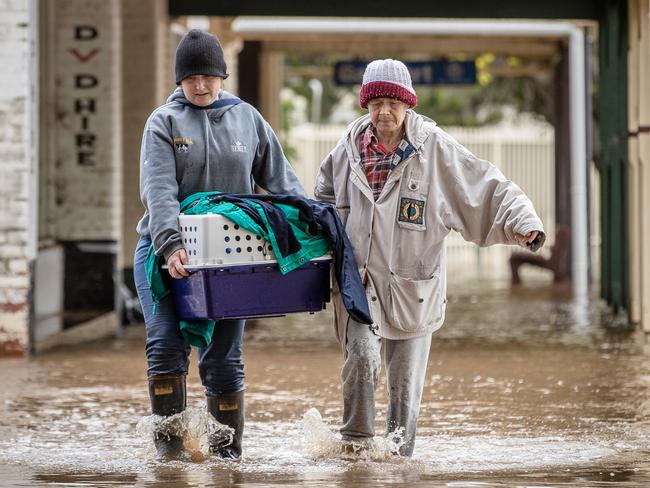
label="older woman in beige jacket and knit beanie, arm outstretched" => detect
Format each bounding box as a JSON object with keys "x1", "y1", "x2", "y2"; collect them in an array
[{"x1": 315, "y1": 59, "x2": 544, "y2": 456}]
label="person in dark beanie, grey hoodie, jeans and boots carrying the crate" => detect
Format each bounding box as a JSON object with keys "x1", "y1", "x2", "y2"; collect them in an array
[{"x1": 134, "y1": 30, "x2": 306, "y2": 459}]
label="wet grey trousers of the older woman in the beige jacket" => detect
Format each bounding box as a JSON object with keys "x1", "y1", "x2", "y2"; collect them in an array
[{"x1": 341, "y1": 319, "x2": 432, "y2": 456}]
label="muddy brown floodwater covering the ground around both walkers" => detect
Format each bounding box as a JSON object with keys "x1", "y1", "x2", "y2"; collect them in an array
[{"x1": 0, "y1": 284, "x2": 650, "y2": 487}]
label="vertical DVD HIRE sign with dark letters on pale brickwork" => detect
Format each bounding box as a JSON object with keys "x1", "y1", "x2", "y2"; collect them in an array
[{"x1": 50, "y1": 0, "x2": 122, "y2": 240}]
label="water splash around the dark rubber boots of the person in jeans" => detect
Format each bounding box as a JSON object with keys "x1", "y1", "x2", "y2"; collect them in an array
[{"x1": 136, "y1": 407, "x2": 234, "y2": 462}]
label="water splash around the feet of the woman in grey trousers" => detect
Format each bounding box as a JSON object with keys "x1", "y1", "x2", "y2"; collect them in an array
[{"x1": 302, "y1": 408, "x2": 404, "y2": 461}]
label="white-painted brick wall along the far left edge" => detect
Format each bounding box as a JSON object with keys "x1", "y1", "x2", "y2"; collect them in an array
[{"x1": 0, "y1": 0, "x2": 33, "y2": 356}]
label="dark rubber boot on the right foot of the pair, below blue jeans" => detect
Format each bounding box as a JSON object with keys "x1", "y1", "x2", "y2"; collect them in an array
[{"x1": 208, "y1": 391, "x2": 244, "y2": 459}]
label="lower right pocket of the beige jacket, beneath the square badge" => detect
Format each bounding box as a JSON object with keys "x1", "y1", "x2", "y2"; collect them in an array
[{"x1": 388, "y1": 273, "x2": 444, "y2": 332}]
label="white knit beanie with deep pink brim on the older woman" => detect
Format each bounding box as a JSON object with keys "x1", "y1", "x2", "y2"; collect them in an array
[{"x1": 359, "y1": 59, "x2": 418, "y2": 108}]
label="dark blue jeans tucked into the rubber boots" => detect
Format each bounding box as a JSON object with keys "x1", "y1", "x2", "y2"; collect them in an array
[{"x1": 133, "y1": 238, "x2": 244, "y2": 396}]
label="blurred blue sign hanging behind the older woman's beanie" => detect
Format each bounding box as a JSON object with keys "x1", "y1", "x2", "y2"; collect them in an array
[{"x1": 334, "y1": 60, "x2": 476, "y2": 85}]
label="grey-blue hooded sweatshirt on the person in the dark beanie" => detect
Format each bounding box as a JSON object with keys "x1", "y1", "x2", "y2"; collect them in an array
[{"x1": 137, "y1": 87, "x2": 306, "y2": 260}]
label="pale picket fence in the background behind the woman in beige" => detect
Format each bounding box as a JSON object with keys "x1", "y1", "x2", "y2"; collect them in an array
[{"x1": 285, "y1": 124, "x2": 600, "y2": 283}]
